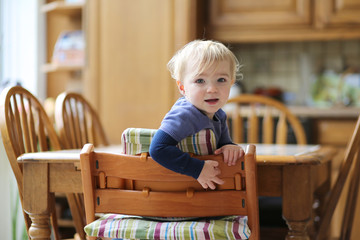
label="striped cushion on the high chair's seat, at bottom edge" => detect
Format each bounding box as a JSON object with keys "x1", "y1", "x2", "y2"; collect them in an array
[{"x1": 85, "y1": 214, "x2": 250, "y2": 240}]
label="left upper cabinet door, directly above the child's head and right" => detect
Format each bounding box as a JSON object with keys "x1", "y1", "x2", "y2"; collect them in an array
[{"x1": 209, "y1": 0, "x2": 311, "y2": 29}]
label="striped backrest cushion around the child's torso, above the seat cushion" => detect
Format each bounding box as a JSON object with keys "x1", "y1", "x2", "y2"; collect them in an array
[{"x1": 122, "y1": 128, "x2": 216, "y2": 155}]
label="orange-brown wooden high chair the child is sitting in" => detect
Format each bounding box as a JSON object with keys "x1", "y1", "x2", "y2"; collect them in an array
[{"x1": 80, "y1": 144, "x2": 259, "y2": 239}]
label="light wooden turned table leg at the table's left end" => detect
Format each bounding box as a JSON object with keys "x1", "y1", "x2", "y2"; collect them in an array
[{"x1": 23, "y1": 163, "x2": 51, "y2": 239}]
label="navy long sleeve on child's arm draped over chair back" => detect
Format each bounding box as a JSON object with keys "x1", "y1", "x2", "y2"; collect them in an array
[{"x1": 149, "y1": 129, "x2": 204, "y2": 179}]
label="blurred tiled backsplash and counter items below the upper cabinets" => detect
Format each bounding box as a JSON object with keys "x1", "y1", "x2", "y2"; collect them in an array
[{"x1": 231, "y1": 40, "x2": 360, "y2": 107}]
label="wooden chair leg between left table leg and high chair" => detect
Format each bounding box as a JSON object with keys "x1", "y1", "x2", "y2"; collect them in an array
[{"x1": 66, "y1": 193, "x2": 86, "y2": 239}]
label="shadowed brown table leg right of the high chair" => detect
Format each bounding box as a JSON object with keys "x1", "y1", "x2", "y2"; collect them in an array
[{"x1": 283, "y1": 165, "x2": 313, "y2": 240}]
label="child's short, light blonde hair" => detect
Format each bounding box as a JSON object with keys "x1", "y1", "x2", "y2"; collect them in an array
[{"x1": 167, "y1": 40, "x2": 240, "y2": 81}]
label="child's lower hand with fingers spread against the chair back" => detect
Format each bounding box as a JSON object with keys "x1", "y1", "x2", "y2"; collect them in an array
[{"x1": 197, "y1": 160, "x2": 224, "y2": 189}]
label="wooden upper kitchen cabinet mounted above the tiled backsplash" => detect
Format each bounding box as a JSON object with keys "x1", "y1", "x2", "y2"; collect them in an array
[{"x1": 205, "y1": 0, "x2": 360, "y2": 43}]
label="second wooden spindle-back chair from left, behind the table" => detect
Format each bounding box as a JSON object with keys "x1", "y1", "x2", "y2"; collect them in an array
[{"x1": 55, "y1": 92, "x2": 109, "y2": 239}]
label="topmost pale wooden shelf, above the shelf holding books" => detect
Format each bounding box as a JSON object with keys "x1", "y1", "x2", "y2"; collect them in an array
[{"x1": 41, "y1": 1, "x2": 85, "y2": 15}]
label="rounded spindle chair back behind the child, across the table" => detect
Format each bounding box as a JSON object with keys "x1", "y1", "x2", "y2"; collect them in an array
[{"x1": 228, "y1": 94, "x2": 306, "y2": 144}]
